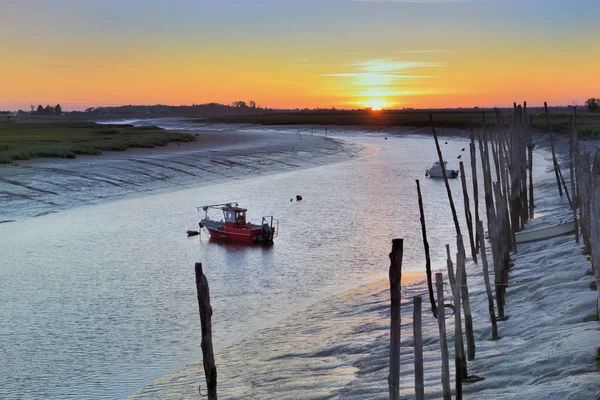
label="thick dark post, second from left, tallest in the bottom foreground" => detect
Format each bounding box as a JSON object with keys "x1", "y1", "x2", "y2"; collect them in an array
[{"x1": 388, "y1": 239, "x2": 404, "y2": 400}]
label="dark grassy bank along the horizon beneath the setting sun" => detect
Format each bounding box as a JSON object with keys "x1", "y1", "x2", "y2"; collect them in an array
[{"x1": 204, "y1": 108, "x2": 600, "y2": 138}]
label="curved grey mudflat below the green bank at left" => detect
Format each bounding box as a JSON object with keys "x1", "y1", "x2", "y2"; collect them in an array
[{"x1": 0, "y1": 129, "x2": 361, "y2": 223}]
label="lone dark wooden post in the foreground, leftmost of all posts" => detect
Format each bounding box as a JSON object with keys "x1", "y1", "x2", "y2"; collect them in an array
[{"x1": 196, "y1": 263, "x2": 217, "y2": 400}]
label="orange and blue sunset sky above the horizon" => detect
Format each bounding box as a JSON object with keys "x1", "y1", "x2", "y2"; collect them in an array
[{"x1": 0, "y1": 0, "x2": 600, "y2": 110}]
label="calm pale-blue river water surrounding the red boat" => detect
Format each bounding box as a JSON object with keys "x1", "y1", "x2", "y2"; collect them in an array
[{"x1": 0, "y1": 132, "x2": 552, "y2": 399}]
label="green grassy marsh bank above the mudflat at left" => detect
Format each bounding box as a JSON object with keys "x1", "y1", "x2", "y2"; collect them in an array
[{"x1": 0, "y1": 118, "x2": 195, "y2": 164}]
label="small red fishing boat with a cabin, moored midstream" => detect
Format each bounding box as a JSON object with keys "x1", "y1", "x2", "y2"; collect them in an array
[{"x1": 198, "y1": 203, "x2": 279, "y2": 244}]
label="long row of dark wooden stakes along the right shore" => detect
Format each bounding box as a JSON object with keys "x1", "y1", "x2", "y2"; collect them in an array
[{"x1": 388, "y1": 104, "x2": 600, "y2": 400}]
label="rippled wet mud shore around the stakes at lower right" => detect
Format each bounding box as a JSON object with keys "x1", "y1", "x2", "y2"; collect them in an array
[{"x1": 129, "y1": 135, "x2": 600, "y2": 400}]
